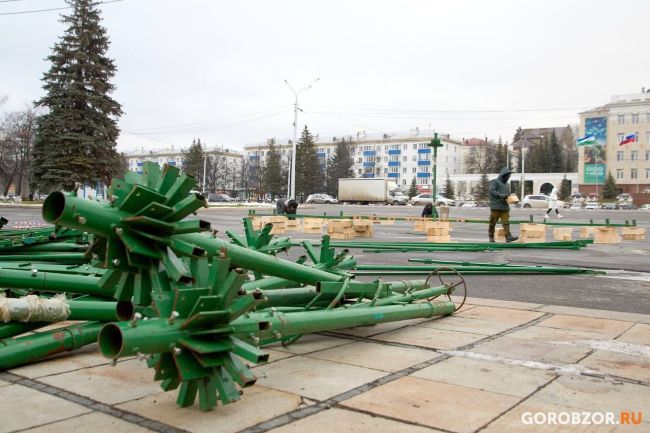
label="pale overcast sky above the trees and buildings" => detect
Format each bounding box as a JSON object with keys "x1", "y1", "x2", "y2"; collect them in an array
[{"x1": 0, "y1": 0, "x2": 650, "y2": 151}]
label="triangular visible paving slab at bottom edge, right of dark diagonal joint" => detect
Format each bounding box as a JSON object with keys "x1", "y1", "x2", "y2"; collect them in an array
[{"x1": 268, "y1": 409, "x2": 440, "y2": 433}]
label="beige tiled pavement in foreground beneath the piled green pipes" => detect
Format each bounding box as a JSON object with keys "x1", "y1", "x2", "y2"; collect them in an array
[{"x1": 0, "y1": 298, "x2": 650, "y2": 433}]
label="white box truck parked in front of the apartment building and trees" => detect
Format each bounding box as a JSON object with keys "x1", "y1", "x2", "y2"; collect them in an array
[{"x1": 338, "y1": 178, "x2": 408, "y2": 205}]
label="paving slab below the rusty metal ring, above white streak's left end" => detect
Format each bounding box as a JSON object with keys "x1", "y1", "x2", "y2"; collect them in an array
[{"x1": 371, "y1": 326, "x2": 485, "y2": 350}]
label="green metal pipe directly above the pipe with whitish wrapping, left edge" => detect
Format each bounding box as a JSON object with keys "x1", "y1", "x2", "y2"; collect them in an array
[{"x1": 0, "y1": 269, "x2": 114, "y2": 297}]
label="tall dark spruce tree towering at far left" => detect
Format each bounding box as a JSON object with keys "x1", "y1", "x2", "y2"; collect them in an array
[{"x1": 32, "y1": 0, "x2": 122, "y2": 191}]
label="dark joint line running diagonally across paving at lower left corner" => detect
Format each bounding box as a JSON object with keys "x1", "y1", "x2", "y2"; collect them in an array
[{"x1": 0, "y1": 372, "x2": 190, "y2": 433}]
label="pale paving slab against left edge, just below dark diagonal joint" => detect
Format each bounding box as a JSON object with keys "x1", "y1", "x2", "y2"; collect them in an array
[{"x1": 0, "y1": 385, "x2": 91, "y2": 433}]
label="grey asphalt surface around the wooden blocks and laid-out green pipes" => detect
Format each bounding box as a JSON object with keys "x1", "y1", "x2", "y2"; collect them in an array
[{"x1": 0, "y1": 205, "x2": 650, "y2": 314}]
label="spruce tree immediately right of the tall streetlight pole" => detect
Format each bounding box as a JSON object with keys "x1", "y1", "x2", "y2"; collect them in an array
[{"x1": 296, "y1": 125, "x2": 324, "y2": 199}]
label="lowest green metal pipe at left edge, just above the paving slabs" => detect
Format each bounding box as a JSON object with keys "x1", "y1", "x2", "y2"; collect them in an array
[{"x1": 0, "y1": 323, "x2": 103, "y2": 370}]
